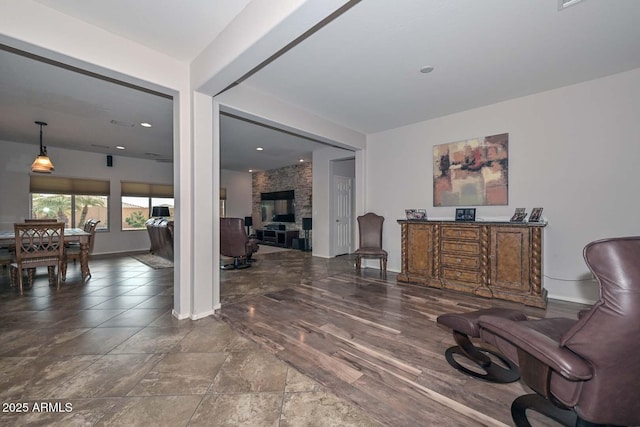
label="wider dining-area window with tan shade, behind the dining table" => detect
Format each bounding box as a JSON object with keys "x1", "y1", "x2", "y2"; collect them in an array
[{"x1": 30, "y1": 176, "x2": 109, "y2": 230}]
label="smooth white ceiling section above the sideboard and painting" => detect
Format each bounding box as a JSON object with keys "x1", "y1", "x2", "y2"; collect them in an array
[{"x1": 245, "y1": 0, "x2": 640, "y2": 133}]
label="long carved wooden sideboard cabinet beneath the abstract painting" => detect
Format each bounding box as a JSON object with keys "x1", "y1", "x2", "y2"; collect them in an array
[{"x1": 398, "y1": 220, "x2": 547, "y2": 308}]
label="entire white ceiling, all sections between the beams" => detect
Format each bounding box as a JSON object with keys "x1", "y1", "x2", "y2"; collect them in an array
[{"x1": 0, "y1": 0, "x2": 640, "y2": 170}]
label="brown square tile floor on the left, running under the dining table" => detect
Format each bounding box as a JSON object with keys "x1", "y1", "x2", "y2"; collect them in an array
[{"x1": 0, "y1": 255, "x2": 379, "y2": 427}]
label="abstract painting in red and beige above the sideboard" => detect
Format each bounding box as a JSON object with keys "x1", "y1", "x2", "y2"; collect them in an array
[{"x1": 433, "y1": 133, "x2": 509, "y2": 206}]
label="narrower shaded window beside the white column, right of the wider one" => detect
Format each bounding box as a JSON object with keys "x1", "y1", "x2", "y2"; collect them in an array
[{"x1": 121, "y1": 182, "x2": 174, "y2": 231}]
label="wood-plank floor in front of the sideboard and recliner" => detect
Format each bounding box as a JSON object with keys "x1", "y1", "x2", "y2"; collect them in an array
[{"x1": 218, "y1": 252, "x2": 584, "y2": 426}]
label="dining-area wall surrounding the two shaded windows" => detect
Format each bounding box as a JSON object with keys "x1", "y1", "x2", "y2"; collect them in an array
[{"x1": 0, "y1": 141, "x2": 173, "y2": 254}]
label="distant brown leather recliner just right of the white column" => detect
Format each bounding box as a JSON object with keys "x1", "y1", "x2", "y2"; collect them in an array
[{"x1": 220, "y1": 218, "x2": 259, "y2": 270}]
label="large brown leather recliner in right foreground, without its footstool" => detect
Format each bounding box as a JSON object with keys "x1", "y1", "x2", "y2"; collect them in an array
[{"x1": 479, "y1": 237, "x2": 640, "y2": 426}]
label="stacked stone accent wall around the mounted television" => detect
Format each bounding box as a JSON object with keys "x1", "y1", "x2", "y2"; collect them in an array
[{"x1": 251, "y1": 162, "x2": 313, "y2": 230}]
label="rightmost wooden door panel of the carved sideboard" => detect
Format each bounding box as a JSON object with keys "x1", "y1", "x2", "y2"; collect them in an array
[{"x1": 490, "y1": 227, "x2": 531, "y2": 295}]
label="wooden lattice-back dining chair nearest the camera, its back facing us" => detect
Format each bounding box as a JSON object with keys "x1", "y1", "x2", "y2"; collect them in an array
[{"x1": 11, "y1": 222, "x2": 64, "y2": 295}]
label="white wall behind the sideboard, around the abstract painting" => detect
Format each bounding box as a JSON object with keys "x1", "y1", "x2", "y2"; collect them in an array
[{"x1": 366, "y1": 69, "x2": 640, "y2": 302}]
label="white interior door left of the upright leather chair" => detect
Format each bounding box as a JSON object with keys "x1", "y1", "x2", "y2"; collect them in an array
[{"x1": 333, "y1": 176, "x2": 353, "y2": 256}]
